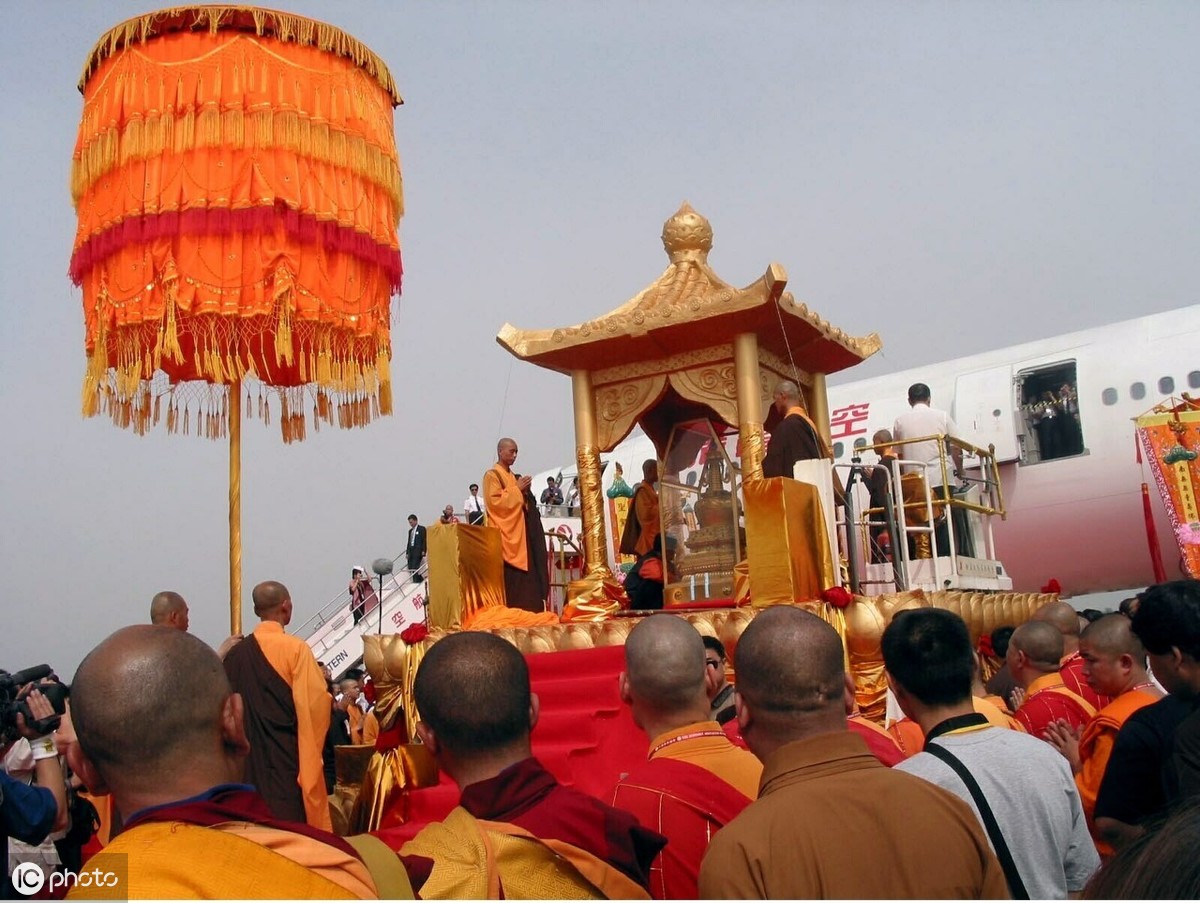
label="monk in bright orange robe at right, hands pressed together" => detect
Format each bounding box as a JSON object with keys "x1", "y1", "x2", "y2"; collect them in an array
[{"x1": 1048, "y1": 615, "x2": 1163, "y2": 856}]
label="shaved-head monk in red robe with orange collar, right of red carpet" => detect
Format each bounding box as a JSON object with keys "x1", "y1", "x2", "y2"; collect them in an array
[{"x1": 612, "y1": 615, "x2": 762, "y2": 899}]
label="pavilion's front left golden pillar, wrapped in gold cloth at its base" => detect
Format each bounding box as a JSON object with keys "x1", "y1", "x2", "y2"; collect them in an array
[{"x1": 563, "y1": 370, "x2": 629, "y2": 621}]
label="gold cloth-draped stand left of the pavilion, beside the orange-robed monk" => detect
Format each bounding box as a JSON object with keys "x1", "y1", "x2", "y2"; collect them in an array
[{"x1": 427, "y1": 524, "x2": 504, "y2": 629}]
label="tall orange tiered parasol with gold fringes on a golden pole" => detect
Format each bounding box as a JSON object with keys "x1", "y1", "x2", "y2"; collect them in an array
[{"x1": 70, "y1": 6, "x2": 403, "y2": 630}]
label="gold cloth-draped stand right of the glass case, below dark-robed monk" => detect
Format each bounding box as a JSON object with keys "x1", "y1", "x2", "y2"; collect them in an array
[{"x1": 742, "y1": 477, "x2": 836, "y2": 608}]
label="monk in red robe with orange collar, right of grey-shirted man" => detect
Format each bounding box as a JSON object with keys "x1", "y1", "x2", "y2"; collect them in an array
[{"x1": 1004, "y1": 619, "x2": 1096, "y2": 740}]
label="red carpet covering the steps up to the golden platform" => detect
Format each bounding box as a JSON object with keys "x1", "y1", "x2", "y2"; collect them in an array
[{"x1": 376, "y1": 646, "x2": 649, "y2": 849}]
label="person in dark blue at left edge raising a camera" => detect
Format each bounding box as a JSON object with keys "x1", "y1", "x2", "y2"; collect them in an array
[{"x1": 0, "y1": 688, "x2": 67, "y2": 899}]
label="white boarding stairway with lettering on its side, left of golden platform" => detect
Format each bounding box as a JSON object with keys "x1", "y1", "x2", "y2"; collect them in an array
[{"x1": 294, "y1": 556, "x2": 428, "y2": 680}]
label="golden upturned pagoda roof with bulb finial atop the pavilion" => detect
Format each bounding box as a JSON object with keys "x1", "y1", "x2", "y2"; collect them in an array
[{"x1": 497, "y1": 202, "x2": 881, "y2": 373}]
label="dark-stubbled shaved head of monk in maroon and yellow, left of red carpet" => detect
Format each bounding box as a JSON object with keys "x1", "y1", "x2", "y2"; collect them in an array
[{"x1": 413, "y1": 630, "x2": 532, "y2": 758}]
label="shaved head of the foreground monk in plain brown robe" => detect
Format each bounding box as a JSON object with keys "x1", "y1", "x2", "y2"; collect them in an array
[{"x1": 737, "y1": 605, "x2": 846, "y2": 758}]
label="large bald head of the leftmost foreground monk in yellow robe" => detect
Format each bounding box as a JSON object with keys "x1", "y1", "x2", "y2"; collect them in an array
[{"x1": 71, "y1": 624, "x2": 230, "y2": 789}]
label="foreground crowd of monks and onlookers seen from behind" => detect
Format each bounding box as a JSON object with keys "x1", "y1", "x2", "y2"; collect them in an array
[{"x1": 21, "y1": 580, "x2": 1200, "y2": 899}]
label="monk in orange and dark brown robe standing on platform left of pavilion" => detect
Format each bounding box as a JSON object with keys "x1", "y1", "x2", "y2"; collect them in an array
[{"x1": 484, "y1": 437, "x2": 548, "y2": 611}]
